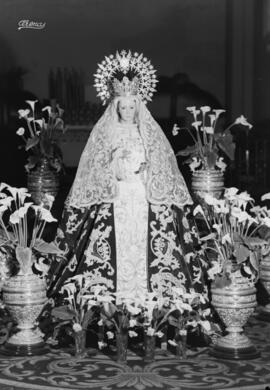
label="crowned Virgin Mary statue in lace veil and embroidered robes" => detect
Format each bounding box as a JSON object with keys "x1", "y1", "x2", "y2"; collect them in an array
[{"x1": 49, "y1": 51, "x2": 206, "y2": 297}]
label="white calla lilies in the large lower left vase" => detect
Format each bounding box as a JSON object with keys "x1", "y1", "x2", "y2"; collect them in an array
[{"x1": 0, "y1": 183, "x2": 62, "y2": 274}]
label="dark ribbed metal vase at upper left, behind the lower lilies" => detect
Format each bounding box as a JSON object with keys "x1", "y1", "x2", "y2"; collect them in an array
[{"x1": 27, "y1": 158, "x2": 59, "y2": 204}]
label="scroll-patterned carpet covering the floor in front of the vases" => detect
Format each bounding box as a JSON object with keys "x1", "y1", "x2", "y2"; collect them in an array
[{"x1": 0, "y1": 317, "x2": 270, "y2": 390}]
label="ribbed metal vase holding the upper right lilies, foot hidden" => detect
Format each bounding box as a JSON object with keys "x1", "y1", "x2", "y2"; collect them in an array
[{"x1": 191, "y1": 168, "x2": 224, "y2": 201}]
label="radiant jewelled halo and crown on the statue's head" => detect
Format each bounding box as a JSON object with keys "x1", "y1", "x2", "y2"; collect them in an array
[{"x1": 94, "y1": 50, "x2": 158, "y2": 104}]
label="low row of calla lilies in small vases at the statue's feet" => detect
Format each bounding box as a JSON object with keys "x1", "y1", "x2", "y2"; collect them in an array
[{"x1": 51, "y1": 275, "x2": 211, "y2": 362}]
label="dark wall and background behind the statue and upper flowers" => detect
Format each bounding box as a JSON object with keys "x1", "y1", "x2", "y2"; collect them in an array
[{"x1": 0, "y1": 0, "x2": 270, "y2": 198}]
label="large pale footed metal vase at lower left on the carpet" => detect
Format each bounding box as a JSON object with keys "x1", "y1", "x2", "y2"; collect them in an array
[{"x1": 1, "y1": 248, "x2": 47, "y2": 356}]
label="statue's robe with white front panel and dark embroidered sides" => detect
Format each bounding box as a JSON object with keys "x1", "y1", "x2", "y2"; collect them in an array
[{"x1": 49, "y1": 124, "x2": 206, "y2": 297}]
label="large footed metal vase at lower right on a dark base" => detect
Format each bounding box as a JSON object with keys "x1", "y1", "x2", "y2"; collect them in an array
[{"x1": 210, "y1": 270, "x2": 259, "y2": 360}]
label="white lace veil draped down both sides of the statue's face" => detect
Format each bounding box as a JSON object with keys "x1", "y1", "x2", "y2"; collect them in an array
[{"x1": 66, "y1": 98, "x2": 193, "y2": 208}]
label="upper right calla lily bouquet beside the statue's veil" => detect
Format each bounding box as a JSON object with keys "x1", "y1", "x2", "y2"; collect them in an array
[{"x1": 172, "y1": 106, "x2": 252, "y2": 172}]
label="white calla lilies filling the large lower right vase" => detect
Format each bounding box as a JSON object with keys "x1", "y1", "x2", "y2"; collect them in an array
[{"x1": 194, "y1": 187, "x2": 270, "y2": 287}]
